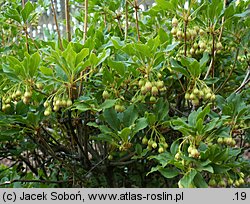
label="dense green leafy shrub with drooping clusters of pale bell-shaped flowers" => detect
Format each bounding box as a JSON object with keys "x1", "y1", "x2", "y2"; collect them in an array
[{"x1": 0, "y1": 0, "x2": 250, "y2": 187}]
